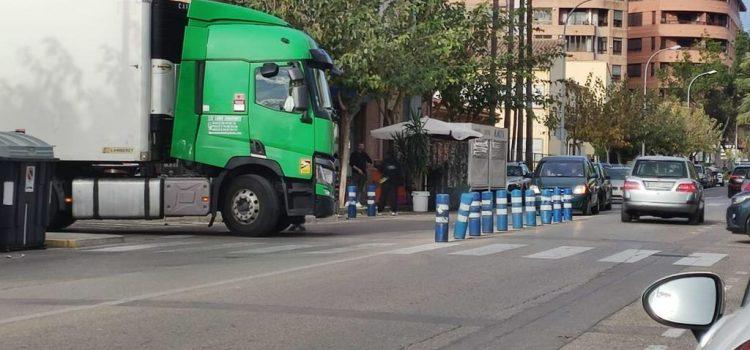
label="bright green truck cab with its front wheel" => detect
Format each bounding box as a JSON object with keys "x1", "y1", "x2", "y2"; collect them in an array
[{"x1": 171, "y1": 1, "x2": 334, "y2": 232}]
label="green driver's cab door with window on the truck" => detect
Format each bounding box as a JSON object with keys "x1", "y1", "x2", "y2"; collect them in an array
[{"x1": 248, "y1": 62, "x2": 315, "y2": 179}]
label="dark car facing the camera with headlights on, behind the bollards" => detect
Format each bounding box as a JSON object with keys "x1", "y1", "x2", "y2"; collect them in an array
[{"x1": 531, "y1": 156, "x2": 603, "y2": 215}]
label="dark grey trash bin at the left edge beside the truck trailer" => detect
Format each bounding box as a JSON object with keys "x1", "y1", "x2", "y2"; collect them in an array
[{"x1": 0, "y1": 132, "x2": 55, "y2": 251}]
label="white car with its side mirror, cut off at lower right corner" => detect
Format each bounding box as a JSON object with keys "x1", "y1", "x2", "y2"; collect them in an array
[{"x1": 642, "y1": 272, "x2": 750, "y2": 350}]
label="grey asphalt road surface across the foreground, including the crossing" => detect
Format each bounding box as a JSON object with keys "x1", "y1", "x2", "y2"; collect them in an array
[{"x1": 0, "y1": 188, "x2": 750, "y2": 350}]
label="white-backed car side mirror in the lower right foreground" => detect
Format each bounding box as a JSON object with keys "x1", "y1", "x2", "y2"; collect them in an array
[{"x1": 641, "y1": 272, "x2": 724, "y2": 338}]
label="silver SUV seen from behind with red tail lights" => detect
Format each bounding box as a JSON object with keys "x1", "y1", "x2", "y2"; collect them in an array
[{"x1": 621, "y1": 156, "x2": 705, "y2": 225}]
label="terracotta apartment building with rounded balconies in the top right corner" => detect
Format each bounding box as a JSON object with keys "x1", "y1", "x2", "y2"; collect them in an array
[{"x1": 627, "y1": 0, "x2": 746, "y2": 87}]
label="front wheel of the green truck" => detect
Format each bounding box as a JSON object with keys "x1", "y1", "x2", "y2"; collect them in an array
[{"x1": 225, "y1": 175, "x2": 282, "y2": 236}]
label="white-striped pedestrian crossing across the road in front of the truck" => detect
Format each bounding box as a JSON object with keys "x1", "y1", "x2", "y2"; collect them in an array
[{"x1": 79, "y1": 238, "x2": 728, "y2": 267}]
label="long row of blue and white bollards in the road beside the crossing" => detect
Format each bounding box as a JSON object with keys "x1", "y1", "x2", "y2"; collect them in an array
[{"x1": 435, "y1": 187, "x2": 573, "y2": 242}]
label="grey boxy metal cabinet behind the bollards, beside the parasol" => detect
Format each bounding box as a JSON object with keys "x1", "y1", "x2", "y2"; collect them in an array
[{"x1": 467, "y1": 124, "x2": 508, "y2": 190}]
